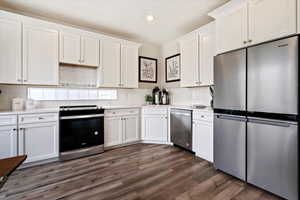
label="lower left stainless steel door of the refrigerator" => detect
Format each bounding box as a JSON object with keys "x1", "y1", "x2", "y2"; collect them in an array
[{"x1": 214, "y1": 114, "x2": 247, "y2": 180}]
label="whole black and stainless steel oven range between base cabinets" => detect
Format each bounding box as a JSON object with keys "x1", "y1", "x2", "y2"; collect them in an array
[{"x1": 59, "y1": 106, "x2": 104, "y2": 160}]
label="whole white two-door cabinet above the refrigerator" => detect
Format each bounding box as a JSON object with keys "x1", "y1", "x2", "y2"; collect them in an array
[{"x1": 209, "y1": 0, "x2": 297, "y2": 53}]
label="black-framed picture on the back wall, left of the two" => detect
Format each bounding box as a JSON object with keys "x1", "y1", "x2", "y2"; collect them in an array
[{"x1": 139, "y1": 56, "x2": 157, "y2": 83}]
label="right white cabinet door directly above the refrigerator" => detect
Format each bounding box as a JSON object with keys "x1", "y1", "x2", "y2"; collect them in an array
[{"x1": 249, "y1": 0, "x2": 297, "y2": 44}]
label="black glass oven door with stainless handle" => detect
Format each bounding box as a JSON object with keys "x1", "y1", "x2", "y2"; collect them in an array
[{"x1": 60, "y1": 115, "x2": 104, "y2": 152}]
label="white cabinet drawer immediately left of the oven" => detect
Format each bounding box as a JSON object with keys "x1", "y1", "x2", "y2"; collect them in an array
[{"x1": 19, "y1": 113, "x2": 58, "y2": 124}]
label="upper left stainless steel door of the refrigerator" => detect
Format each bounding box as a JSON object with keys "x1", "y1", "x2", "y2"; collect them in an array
[{"x1": 214, "y1": 49, "x2": 246, "y2": 111}]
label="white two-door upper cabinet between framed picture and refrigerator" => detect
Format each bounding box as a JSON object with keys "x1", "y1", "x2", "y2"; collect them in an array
[{"x1": 179, "y1": 22, "x2": 216, "y2": 87}]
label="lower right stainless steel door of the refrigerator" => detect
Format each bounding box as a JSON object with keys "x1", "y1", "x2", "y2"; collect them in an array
[{"x1": 247, "y1": 118, "x2": 298, "y2": 200}]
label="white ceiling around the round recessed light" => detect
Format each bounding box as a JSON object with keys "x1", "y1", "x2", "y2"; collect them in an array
[{"x1": 0, "y1": 0, "x2": 229, "y2": 45}]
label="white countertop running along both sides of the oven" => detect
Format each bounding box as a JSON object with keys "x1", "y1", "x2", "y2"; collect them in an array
[{"x1": 0, "y1": 105, "x2": 212, "y2": 115}]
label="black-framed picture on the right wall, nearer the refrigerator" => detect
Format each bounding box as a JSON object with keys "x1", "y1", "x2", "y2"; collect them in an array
[{"x1": 165, "y1": 54, "x2": 180, "y2": 83}]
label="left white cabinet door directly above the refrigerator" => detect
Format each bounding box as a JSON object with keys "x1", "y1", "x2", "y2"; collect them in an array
[{"x1": 216, "y1": 4, "x2": 248, "y2": 53}]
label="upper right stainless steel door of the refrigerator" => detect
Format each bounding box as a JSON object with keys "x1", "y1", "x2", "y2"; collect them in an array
[{"x1": 247, "y1": 37, "x2": 298, "y2": 114}]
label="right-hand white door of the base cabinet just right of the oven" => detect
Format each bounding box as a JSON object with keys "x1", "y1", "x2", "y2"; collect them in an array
[{"x1": 123, "y1": 115, "x2": 140, "y2": 143}]
